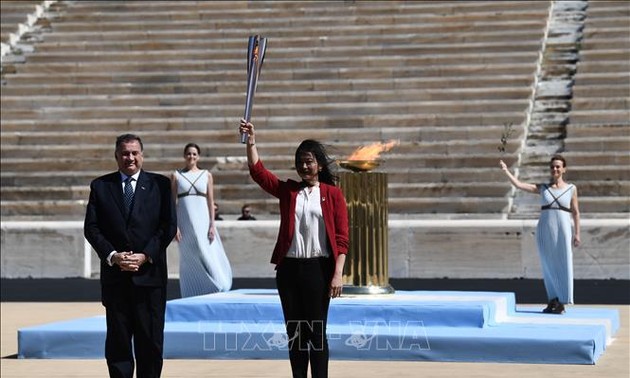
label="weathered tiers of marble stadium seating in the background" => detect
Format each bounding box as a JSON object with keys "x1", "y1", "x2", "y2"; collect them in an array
[{"x1": 0, "y1": 1, "x2": 630, "y2": 220}]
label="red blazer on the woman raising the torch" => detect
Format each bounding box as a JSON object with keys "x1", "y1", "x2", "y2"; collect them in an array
[{"x1": 249, "y1": 159, "x2": 349, "y2": 265}]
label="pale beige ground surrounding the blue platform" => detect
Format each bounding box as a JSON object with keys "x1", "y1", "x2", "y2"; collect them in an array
[{"x1": 0, "y1": 302, "x2": 630, "y2": 378}]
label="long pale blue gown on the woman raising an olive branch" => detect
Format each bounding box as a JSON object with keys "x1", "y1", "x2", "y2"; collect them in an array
[{"x1": 536, "y1": 185, "x2": 575, "y2": 304}]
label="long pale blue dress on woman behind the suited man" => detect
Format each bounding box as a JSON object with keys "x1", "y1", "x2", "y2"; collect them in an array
[{"x1": 175, "y1": 170, "x2": 232, "y2": 298}]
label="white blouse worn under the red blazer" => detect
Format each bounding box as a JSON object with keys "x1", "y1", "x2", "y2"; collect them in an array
[{"x1": 286, "y1": 186, "x2": 330, "y2": 259}]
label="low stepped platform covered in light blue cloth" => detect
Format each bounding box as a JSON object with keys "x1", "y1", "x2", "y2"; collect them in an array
[{"x1": 18, "y1": 289, "x2": 619, "y2": 364}]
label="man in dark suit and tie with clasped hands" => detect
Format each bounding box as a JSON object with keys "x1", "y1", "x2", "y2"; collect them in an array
[{"x1": 84, "y1": 134, "x2": 177, "y2": 378}]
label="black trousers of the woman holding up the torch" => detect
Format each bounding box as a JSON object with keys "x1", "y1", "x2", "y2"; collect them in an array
[{"x1": 276, "y1": 258, "x2": 335, "y2": 378}]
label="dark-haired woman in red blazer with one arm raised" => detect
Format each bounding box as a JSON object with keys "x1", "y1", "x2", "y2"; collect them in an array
[{"x1": 239, "y1": 120, "x2": 348, "y2": 378}]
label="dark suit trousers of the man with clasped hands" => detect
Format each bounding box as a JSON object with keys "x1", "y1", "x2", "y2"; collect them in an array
[{"x1": 102, "y1": 280, "x2": 166, "y2": 378}]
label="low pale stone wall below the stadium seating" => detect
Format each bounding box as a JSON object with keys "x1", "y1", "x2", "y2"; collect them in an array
[{"x1": 0, "y1": 219, "x2": 630, "y2": 280}]
